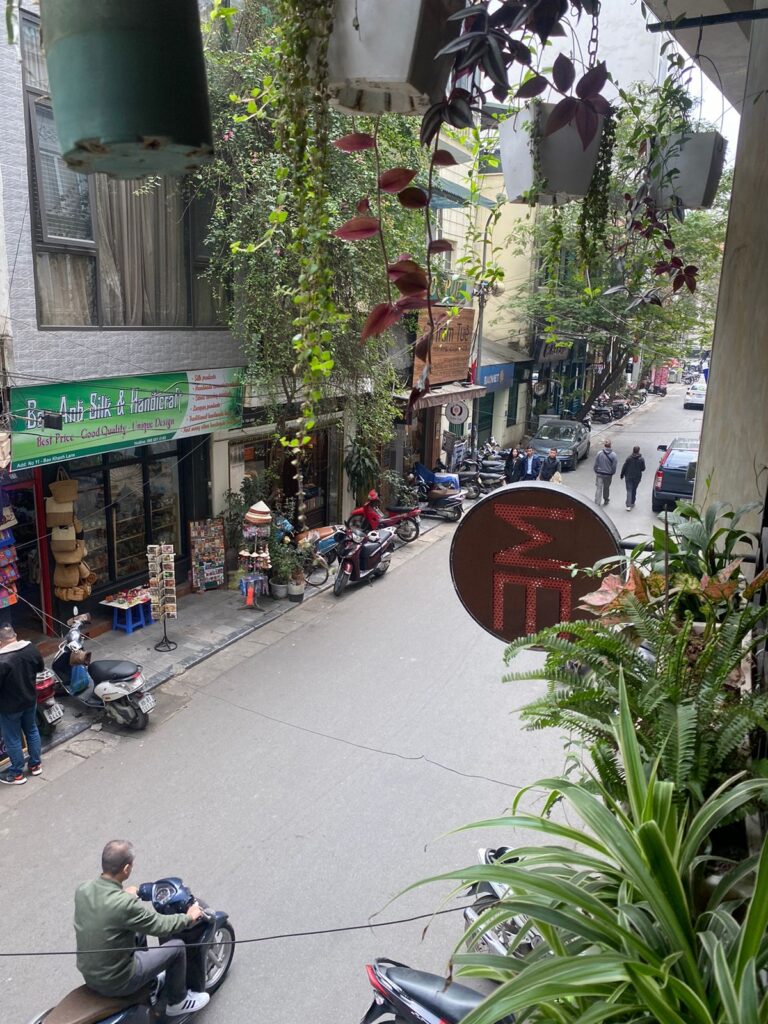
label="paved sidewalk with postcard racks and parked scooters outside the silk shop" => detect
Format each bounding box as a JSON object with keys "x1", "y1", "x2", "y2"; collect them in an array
[{"x1": 43, "y1": 518, "x2": 451, "y2": 752}]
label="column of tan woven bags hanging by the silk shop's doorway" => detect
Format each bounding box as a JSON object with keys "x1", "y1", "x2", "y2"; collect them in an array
[{"x1": 45, "y1": 469, "x2": 96, "y2": 601}]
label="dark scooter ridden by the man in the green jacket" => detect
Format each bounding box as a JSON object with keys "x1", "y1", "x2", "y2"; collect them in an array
[{"x1": 30, "y1": 878, "x2": 234, "y2": 1024}]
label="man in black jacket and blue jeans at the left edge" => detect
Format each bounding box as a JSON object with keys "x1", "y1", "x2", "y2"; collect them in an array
[{"x1": 0, "y1": 626, "x2": 45, "y2": 785}]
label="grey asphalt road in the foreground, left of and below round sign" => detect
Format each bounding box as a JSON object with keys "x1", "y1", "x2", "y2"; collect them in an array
[{"x1": 0, "y1": 523, "x2": 562, "y2": 1024}]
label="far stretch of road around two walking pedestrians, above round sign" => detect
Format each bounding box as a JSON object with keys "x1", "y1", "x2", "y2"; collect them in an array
[{"x1": 563, "y1": 384, "x2": 703, "y2": 539}]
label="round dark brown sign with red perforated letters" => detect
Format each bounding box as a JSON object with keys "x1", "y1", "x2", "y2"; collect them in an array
[{"x1": 451, "y1": 482, "x2": 621, "y2": 642}]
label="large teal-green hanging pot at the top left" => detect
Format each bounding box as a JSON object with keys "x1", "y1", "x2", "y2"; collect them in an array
[{"x1": 41, "y1": 0, "x2": 213, "y2": 178}]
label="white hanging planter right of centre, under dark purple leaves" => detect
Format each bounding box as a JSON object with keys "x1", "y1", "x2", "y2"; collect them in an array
[{"x1": 499, "y1": 102, "x2": 603, "y2": 205}]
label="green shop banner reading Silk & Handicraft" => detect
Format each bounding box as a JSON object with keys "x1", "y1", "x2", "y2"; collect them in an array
[{"x1": 10, "y1": 369, "x2": 243, "y2": 469}]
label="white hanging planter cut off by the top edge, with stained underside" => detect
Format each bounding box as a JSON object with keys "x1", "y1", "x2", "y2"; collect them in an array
[{"x1": 328, "y1": 0, "x2": 465, "y2": 114}]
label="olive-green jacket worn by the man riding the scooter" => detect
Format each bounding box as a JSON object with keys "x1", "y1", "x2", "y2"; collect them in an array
[{"x1": 75, "y1": 878, "x2": 194, "y2": 995}]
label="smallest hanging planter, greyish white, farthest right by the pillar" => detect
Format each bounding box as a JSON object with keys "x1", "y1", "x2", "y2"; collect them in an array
[{"x1": 653, "y1": 131, "x2": 727, "y2": 210}]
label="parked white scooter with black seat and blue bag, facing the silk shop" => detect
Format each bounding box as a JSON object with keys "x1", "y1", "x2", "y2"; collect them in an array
[{"x1": 51, "y1": 607, "x2": 155, "y2": 731}]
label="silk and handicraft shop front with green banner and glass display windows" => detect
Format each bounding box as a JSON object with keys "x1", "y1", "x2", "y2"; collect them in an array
[{"x1": 7, "y1": 370, "x2": 242, "y2": 633}]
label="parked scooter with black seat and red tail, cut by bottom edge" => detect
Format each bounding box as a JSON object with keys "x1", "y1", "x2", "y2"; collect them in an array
[{"x1": 361, "y1": 957, "x2": 507, "y2": 1024}]
